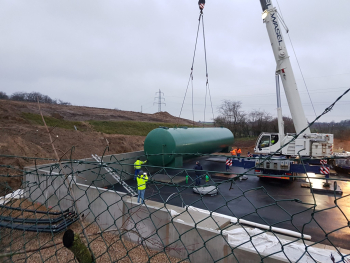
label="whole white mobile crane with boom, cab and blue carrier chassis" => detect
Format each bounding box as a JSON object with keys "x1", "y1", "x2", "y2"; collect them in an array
[{"x1": 228, "y1": 0, "x2": 333, "y2": 179}]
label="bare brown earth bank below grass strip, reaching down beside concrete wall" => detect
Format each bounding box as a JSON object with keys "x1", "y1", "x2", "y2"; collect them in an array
[{"x1": 0, "y1": 124, "x2": 145, "y2": 195}]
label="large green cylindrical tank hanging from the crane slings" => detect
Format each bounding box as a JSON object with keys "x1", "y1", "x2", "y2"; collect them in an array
[{"x1": 144, "y1": 127, "x2": 233, "y2": 167}]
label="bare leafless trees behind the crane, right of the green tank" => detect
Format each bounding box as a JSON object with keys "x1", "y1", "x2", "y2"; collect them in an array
[{"x1": 214, "y1": 100, "x2": 350, "y2": 139}]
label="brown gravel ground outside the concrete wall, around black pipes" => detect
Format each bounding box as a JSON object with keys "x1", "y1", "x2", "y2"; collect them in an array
[{"x1": 0, "y1": 200, "x2": 187, "y2": 263}]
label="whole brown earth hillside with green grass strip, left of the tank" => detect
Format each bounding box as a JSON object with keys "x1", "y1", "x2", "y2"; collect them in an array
[{"x1": 0, "y1": 100, "x2": 198, "y2": 191}]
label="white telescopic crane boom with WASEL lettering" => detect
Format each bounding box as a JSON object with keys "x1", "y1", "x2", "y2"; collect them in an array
[{"x1": 260, "y1": 0, "x2": 310, "y2": 134}]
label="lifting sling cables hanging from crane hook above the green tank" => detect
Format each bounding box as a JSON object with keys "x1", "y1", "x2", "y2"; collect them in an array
[{"x1": 179, "y1": 0, "x2": 214, "y2": 126}]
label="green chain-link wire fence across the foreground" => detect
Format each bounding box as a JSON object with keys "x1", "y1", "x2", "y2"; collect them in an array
[{"x1": 0, "y1": 90, "x2": 350, "y2": 262}]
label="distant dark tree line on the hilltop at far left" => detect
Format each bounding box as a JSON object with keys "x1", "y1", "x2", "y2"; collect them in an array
[{"x1": 0, "y1": 91, "x2": 71, "y2": 105}]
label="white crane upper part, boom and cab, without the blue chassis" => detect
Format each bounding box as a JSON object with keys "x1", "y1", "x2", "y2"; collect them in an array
[{"x1": 255, "y1": 0, "x2": 333, "y2": 158}]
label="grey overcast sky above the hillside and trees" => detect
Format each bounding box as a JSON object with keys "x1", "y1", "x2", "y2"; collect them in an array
[{"x1": 0, "y1": 0, "x2": 350, "y2": 124}]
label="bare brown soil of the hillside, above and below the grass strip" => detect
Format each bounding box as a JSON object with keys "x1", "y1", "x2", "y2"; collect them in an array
[{"x1": 0, "y1": 100, "x2": 192, "y2": 173}]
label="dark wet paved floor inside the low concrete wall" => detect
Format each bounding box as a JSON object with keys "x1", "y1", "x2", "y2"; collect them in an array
[{"x1": 113, "y1": 157, "x2": 350, "y2": 252}]
